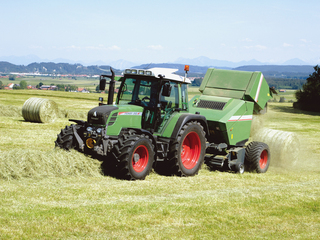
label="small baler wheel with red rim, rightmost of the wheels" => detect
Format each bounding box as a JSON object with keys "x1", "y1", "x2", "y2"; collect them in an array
[{"x1": 245, "y1": 142, "x2": 270, "y2": 173}]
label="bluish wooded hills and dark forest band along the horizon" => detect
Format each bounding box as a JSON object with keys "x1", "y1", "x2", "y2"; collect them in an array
[{"x1": 0, "y1": 61, "x2": 314, "y2": 89}]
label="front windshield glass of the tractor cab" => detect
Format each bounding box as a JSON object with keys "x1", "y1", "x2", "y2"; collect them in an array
[{"x1": 118, "y1": 77, "x2": 159, "y2": 108}]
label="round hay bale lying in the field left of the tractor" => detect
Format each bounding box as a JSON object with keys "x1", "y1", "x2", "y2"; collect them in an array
[{"x1": 22, "y1": 98, "x2": 58, "y2": 123}]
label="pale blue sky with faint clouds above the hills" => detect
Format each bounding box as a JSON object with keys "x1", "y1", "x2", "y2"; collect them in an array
[{"x1": 0, "y1": 0, "x2": 320, "y2": 63}]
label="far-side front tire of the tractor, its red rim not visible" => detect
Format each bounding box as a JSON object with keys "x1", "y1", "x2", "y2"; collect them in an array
[{"x1": 55, "y1": 124, "x2": 80, "y2": 150}]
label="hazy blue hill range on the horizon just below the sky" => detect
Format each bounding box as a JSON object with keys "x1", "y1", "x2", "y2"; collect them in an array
[{"x1": 0, "y1": 62, "x2": 314, "y2": 79}]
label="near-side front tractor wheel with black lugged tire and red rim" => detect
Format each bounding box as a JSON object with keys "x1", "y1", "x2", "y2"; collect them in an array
[{"x1": 115, "y1": 130, "x2": 155, "y2": 180}]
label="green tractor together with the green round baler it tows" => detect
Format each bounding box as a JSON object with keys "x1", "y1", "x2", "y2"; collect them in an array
[{"x1": 55, "y1": 65, "x2": 272, "y2": 180}]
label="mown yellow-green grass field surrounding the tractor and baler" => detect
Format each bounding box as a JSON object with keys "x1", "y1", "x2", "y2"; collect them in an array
[{"x1": 0, "y1": 89, "x2": 320, "y2": 239}]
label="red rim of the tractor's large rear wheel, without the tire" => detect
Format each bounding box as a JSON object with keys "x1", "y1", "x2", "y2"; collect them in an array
[{"x1": 181, "y1": 132, "x2": 201, "y2": 169}]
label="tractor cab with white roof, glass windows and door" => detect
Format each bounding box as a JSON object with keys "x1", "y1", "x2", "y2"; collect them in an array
[{"x1": 100, "y1": 68, "x2": 190, "y2": 133}]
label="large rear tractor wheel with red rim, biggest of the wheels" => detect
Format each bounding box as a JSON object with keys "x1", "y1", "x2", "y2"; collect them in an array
[{"x1": 168, "y1": 121, "x2": 206, "y2": 177}]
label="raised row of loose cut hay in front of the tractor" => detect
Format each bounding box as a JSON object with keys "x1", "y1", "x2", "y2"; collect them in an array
[{"x1": 0, "y1": 149, "x2": 102, "y2": 180}]
